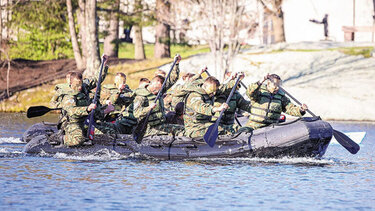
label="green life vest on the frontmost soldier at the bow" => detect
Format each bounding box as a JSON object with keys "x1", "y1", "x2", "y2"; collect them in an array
[{"x1": 249, "y1": 85, "x2": 285, "y2": 124}]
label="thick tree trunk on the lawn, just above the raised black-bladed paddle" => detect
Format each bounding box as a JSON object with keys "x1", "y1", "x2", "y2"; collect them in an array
[{"x1": 154, "y1": 0, "x2": 171, "y2": 58}]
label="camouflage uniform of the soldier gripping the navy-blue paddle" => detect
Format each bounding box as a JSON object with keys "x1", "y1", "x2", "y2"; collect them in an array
[{"x1": 184, "y1": 80, "x2": 235, "y2": 138}]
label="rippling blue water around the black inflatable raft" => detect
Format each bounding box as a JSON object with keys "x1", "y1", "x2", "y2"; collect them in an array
[{"x1": 0, "y1": 113, "x2": 375, "y2": 210}]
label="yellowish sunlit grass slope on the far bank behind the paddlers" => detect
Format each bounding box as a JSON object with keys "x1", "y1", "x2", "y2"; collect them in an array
[{"x1": 0, "y1": 44, "x2": 209, "y2": 112}]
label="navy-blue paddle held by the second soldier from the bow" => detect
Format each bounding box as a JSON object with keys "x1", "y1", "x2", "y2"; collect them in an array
[{"x1": 203, "y1": 76, "x2": 241, "y2": 147}]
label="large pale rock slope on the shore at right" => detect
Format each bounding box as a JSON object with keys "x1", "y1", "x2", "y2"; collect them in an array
[{"x1": 170, "y1": 42, "x2": 375, "y2": 121}]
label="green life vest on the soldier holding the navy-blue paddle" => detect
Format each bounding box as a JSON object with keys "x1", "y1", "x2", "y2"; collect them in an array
[{"x1": 184, "y1": 88, "x2": 214, "y2": 124}]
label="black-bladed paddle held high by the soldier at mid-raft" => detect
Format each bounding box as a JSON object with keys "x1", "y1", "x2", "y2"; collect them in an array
[{"x1": 133, "y1": 54, "x2": 179, "y2": 144}]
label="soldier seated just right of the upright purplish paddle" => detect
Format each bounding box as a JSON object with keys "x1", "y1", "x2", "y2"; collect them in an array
[{"x1": 101, "y1": 72, "x2": 133, "y2": 122}]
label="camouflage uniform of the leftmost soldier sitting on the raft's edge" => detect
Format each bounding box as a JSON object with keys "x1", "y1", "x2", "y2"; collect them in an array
[{"x1": 62, "y1": 92, "x2": 103, "y2": 146}]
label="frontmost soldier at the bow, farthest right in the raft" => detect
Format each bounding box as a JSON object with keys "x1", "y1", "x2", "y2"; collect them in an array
[{"x1": 246, "y1": 74, "x2": 308, "y2": 130}]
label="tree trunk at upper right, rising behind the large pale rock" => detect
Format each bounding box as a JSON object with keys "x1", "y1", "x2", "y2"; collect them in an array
[{"x1": 259, "y1": 0, "x2": 285, "y2": 43}]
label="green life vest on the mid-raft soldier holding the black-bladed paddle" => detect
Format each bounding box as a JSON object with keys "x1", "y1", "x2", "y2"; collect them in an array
[{"x1": 135, "y1": 88, "x2": 166, "y2": 127}]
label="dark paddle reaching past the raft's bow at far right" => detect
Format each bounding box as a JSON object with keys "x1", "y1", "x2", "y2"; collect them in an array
[{"x1": 271, "y1": 80, "x2": 360, "y2": 154}]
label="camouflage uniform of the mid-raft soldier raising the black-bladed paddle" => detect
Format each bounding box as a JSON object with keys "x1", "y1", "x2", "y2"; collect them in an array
[{"x1": 134, "y1": 64, "x2": 183, "y2": 136}]
